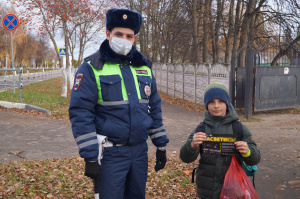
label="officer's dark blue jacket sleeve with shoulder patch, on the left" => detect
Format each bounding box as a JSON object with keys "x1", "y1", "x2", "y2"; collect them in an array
[{"x1": 69, "y1": 62, "x2": 99, "y2": 161}]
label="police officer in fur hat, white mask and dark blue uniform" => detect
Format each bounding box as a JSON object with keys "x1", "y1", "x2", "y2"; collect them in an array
[{"x1": 69, "y1": 9, "x2": 169, "y2": 199}]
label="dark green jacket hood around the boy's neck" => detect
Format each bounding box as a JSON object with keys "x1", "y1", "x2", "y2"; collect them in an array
[{"x1": 204, "y1": 104, "x2": 239, "y2": 126}]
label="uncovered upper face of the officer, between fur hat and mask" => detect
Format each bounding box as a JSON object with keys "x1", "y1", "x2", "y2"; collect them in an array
[{"x1": 106, "y1": 27, "x2": 137, "y2": 42}]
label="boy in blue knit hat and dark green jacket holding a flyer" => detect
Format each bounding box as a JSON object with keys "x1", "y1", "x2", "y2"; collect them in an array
[{"x1": 180, "y1": 82, "x2": 260, "y2": 199}]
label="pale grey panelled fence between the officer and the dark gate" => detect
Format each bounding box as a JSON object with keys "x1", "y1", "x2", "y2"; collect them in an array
[{"x1": 152, "y1": 64, "x2": 230, "y2": 104}]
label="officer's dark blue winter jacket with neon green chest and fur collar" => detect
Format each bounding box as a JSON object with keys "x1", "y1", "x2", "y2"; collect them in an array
[{"x1": 69, "y1": 40, "x2": 169, "y2": 161}]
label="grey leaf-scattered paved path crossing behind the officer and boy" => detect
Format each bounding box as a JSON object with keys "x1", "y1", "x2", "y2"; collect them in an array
[{"x1": 0, "y1": 103, "x2": 300, "y2": 199}]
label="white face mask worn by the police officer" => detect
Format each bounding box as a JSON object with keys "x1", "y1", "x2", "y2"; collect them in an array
[{"x1": 109, "y1": 37, "x2": 133, "y2": 55}]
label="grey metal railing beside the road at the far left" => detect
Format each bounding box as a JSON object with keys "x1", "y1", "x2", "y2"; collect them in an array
[{"x1": 0, "y1": 68, "x2": 62, "y2": 103}]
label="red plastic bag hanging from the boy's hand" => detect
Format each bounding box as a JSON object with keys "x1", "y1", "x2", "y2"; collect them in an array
[{"x1": 220, "y1": 156, "x2": 258, "y2": 199}]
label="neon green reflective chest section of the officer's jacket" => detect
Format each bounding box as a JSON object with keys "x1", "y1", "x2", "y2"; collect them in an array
[{"x1": 88, "y1": 61, "x2": 152, "y2": 106}]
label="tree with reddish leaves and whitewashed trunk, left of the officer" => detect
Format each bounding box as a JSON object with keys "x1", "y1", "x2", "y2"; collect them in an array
[{"x1": 12, "y1": 0, "x2": 119, "y2": 97}]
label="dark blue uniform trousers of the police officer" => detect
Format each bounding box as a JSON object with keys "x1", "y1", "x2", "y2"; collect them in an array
[{"x1": 99, "y1": 142, "x2": 148, "y2": 199}]
